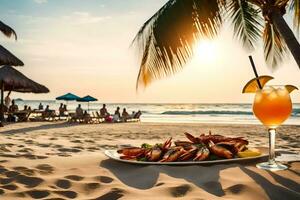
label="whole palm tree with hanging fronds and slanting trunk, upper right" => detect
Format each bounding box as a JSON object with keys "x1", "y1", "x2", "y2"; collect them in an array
[{"x1": 133, "y1": 0, "x2": 300, "y2": 87}]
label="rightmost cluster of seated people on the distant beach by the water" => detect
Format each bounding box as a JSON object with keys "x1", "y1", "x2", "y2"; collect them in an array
[{"x1": 100, "y1": 104, "x2": 142, "y2": 122}]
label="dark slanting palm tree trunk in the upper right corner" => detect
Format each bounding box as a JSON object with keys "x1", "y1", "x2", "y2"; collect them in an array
[{"x1": 271, "y1": 11, "x2": 300, "y2": 68}]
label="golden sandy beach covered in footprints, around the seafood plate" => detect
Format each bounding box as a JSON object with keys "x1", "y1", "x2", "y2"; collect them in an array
[{"x1": 0, "y1": 122, "x2": 300, "y2": 200}]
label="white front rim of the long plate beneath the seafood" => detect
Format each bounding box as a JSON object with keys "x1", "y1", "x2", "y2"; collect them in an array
[{"x1": 104, "y1": 148, "x2": 268, "y2": 165}]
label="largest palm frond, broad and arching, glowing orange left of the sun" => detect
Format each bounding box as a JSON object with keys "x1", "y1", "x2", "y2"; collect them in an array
[{"x1": 133, "y1": 0, "x2": 223, "y2": 88}]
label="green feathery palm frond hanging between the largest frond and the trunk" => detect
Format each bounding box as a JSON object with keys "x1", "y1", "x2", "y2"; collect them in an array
[{"x1": 228, "y1": 0, "x2": 263, "y2": 50}]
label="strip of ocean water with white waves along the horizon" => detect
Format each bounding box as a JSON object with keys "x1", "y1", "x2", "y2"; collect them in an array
[{"x1": 16, "y1": 100, "x2": 300, "y2": 125}]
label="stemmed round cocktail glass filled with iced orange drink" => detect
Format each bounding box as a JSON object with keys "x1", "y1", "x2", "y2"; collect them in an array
[{"x1": 253, "y1": 86, "x2": 292, "y2": 171}]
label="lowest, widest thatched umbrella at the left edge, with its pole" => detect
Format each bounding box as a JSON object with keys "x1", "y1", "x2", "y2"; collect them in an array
[{"x1": 0, "y1": 65, "x2": 49, "y2": 120}]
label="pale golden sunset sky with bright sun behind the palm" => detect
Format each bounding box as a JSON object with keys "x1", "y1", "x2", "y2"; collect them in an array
[{"x1": 0, "y1": 0, "x2": 300, "y2": 103}]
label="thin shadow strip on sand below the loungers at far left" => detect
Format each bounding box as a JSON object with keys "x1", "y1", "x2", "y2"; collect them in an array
[{"x1": 0, "y1": 122, "x2": 79, "y2": 134}]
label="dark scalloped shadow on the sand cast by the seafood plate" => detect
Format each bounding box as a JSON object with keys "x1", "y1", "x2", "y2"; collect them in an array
[{"x1": 100, "y1": 159, "x2": 251, "y2": 197}]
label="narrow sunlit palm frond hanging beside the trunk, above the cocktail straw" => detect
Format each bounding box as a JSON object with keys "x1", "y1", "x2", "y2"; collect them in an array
[{"x1": 263, "y1": 23, "x2": 288, "y2": 69}]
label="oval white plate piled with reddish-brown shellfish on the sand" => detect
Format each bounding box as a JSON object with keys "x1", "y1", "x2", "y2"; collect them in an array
[{"x1": 104, "y1": 133, "x2": 268, "y2": 165}]
